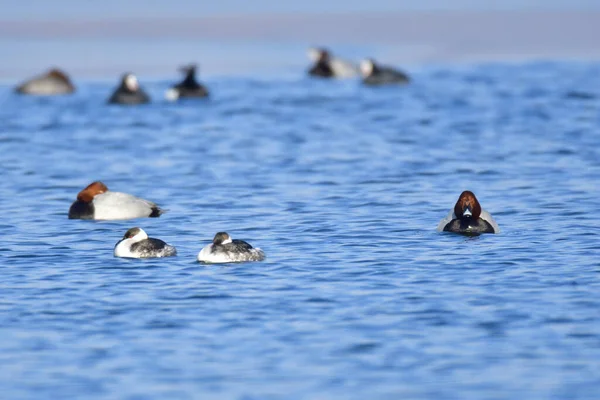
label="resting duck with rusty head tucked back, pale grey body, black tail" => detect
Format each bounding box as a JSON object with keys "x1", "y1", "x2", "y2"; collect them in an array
[{"x1": 69, "y1": 181, "x2": 164, "y2": 221}]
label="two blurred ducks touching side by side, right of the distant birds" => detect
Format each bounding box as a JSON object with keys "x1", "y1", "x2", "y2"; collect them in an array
[{"x1": 308, "y1": 48, "x2": 410, "y2": 86}]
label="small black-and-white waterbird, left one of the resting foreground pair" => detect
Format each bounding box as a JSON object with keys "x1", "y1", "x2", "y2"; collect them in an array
[{"x1": 114, "y1": 227, "x2": 177, "y2": 258}]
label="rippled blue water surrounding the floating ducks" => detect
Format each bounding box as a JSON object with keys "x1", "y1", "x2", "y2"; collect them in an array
[{"x1": 0, "y1": 62, "x2": 600, "y2": 400}]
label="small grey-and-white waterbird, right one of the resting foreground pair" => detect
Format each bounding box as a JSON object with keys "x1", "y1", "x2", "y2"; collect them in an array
[{"x1": 198, "y1": 232, "x2": 265, "y2": 264}]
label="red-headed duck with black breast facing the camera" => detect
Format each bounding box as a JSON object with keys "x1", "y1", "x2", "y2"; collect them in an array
[{"x1": 437, "y1": 190, "x2": 500, "y2": 235}]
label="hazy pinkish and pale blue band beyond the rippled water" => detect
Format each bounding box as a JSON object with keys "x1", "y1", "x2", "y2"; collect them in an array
[{"x1": 0, "y1": 10, "x2": 600, "y2": 80}]
